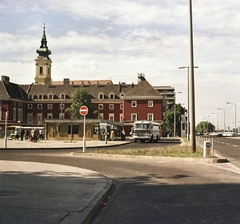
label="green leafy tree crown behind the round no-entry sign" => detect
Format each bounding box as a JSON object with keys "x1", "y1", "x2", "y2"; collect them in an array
[{"x1": 65, "y1": 89, "x2": 98, "y2": 119}]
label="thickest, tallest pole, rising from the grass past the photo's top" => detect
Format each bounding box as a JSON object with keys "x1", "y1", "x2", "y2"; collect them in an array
[{"x1": 189, "y1": 0, "x2": 196, "y2": 153}]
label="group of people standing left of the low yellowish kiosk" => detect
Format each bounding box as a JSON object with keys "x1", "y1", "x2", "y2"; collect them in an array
[{"x1": 14, "y1": 128, "x2": 44, "y2": 142}]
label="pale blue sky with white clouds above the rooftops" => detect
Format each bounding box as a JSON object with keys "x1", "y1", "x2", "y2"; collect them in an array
[{"x1": 0, "y1": 0, "x2": 240, "y2": 129}]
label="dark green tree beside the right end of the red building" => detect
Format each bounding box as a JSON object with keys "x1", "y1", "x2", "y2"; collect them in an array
[{"x1": 163, "y1": 103, "x2": 187, "y2": 136}]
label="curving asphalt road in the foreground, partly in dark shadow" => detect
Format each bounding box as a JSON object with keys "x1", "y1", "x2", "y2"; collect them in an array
[{"x1": 0, "y1": 143, "x2": 240, "y2": 224}]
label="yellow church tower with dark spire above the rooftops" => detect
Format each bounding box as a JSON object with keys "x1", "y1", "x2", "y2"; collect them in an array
[{"x1": 35, "y1": 25, "x2": 52, "y2": 85}]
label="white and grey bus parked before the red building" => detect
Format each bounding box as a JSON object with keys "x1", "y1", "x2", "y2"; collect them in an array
[{"x1": 132, "y1": 121, "x2": 160, "y2": 142}]
